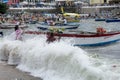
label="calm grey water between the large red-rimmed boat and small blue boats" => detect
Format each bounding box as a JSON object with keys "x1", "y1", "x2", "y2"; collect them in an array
[{"x1": 79, "y1": 19, "x2": 120, "y2": 32}]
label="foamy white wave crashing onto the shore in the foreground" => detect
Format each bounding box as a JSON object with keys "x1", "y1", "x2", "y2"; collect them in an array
[{"x1": 0, "y1": 36, "x2": 120, "y2": 80}]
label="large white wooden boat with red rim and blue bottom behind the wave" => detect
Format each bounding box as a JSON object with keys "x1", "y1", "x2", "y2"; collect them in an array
[{"x1": 25, "y1": 31, "x2": 120, "y2": 46}]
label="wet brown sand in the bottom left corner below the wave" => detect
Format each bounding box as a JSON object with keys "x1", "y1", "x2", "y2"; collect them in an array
[{"x1": 0, "y1": 62, "x2": 42, "y2": 80}]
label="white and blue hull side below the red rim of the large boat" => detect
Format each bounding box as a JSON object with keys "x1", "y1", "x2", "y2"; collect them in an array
[{"x1": 66, "y1": 34, "x2": 120, "y2": 46}]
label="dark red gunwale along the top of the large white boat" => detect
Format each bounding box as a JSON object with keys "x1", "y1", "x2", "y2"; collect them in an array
[{"x1": 25, "y1": 31, "x2": 120, "y2": 38}]
